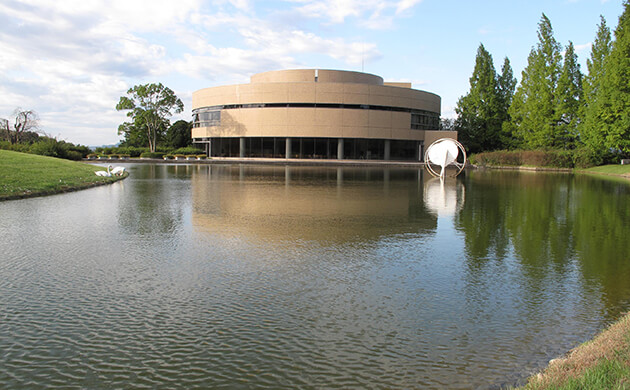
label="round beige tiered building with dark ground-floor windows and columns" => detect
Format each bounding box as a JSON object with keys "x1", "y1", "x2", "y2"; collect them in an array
[{"x1": 192, "y1": 69, "x2": 457, "y2": 161}]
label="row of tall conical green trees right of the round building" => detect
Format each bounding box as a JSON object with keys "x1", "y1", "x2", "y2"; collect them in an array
[{"x1": 454, "y1": 0, "x2": 630, "y2": 155}]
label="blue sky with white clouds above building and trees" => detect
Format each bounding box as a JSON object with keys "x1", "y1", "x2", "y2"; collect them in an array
[{"x1": 0, "y1": 0, "x2": 623, "y2": 145}]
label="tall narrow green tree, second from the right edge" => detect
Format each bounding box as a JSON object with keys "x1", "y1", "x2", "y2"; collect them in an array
[{"x1": 579, "y1": 16, "x2": 612, "y2": 153}]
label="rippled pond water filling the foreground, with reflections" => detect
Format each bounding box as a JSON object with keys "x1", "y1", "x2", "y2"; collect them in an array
[{"x1": 0, "y1": 165, "x2": 630, "y2": 389}]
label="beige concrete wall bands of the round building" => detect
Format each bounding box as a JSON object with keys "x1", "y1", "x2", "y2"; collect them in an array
[{"x1": 192, "y1": 69, "x2": 444, "y2": 145}]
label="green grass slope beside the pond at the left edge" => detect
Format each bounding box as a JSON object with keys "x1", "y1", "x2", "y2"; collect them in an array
[{"x1": 0, "y1": 150, "x2": 126, "y2": 200}]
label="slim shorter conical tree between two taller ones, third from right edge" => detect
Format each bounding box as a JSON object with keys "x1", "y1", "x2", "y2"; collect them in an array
[{"x1": 553, "y1": 41, "x2": 582, "y2": 149}]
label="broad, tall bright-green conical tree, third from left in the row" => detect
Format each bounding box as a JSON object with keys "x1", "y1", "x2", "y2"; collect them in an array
[{"x1": 509, "y1": 14, "x2": 562, "y2": 148}]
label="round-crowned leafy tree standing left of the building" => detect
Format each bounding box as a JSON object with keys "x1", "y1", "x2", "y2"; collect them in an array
[{"x1": 116, "y1": 83, "x2": 184, "y2": 152}]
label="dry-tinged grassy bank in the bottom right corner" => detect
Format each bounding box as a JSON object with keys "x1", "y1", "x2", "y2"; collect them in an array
[{"x1": 521, "y1": 313, "x2": 630, "y2": 390}]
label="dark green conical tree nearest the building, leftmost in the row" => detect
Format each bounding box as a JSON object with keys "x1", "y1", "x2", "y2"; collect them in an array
[{"x1": 455, "y1": 44, "x2": 501, "y2": 153}]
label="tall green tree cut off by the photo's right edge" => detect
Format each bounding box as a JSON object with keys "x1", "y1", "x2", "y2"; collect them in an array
[{"x1": 597, "y1": 0, "x2": 630, "y2": 154}]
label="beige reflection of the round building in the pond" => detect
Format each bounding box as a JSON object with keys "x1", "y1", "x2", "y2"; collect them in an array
[{"x1": 191, "y1": 165, "x2": 451, "y2": 243}]
